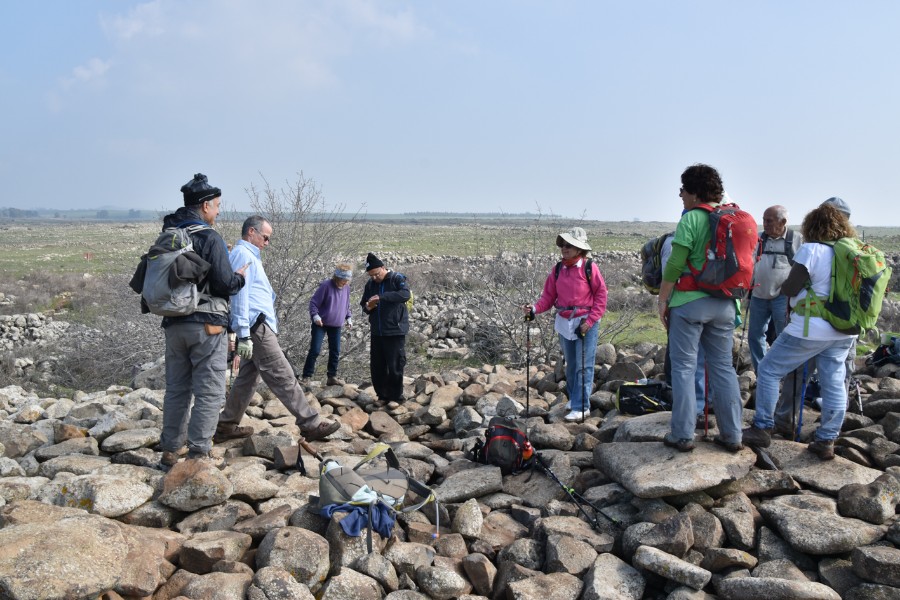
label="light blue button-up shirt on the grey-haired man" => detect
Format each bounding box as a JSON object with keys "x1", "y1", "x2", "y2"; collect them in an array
[{"x1": 228, "y1": 240, "x2": 278, "y2": 338}]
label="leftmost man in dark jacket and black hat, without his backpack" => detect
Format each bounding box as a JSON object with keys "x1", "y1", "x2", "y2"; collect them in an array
[{"x1": 159, "y1": 173, "x2": 247, "y2": 466}]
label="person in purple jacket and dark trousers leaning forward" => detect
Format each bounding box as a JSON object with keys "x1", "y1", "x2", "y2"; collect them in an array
[{"x1": 303, "y1": 263, "x2": 353, "y2": 385}]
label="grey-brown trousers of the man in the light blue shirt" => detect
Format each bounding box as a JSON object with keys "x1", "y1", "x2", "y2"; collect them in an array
[{"x1": 219, "y1": 323, "x2": 320, "y2": 432}]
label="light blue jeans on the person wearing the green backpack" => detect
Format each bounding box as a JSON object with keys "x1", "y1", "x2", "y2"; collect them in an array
[{"x1": 753, "y1": 333, "x2": 853, "y2": 440}]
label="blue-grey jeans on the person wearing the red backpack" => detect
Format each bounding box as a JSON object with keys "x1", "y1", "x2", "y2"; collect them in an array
[{"x1": 669, "y1": 297, "x2": 742, "y2": 442}]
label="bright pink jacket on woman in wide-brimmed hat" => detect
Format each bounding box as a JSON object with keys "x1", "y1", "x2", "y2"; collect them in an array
[{"x1": 534, "y1": 258, "x2": 606, "y2": 327}]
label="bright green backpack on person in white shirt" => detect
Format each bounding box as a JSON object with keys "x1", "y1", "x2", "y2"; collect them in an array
[{"x1": 795, "y1": 238, "x2": 891, "y2": 335}]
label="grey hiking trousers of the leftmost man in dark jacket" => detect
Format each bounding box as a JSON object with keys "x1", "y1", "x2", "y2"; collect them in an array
[{"x1": 159, "y1": 322, "x2": 228, "y2": 453}]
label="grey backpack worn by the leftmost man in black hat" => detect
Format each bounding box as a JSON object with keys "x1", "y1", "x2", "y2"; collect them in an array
[{"x1": 141, "y1": 224, "x2": 209, "y2": 317}]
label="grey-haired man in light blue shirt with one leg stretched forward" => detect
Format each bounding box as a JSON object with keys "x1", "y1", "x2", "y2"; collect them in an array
[{"x1": 213, "y1": 215, "x2": 341, "y2": 443}]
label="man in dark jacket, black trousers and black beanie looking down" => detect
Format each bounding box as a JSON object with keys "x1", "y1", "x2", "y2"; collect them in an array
[{"x1": 360, "y1": 252, "x2": 412, "y2": 402}]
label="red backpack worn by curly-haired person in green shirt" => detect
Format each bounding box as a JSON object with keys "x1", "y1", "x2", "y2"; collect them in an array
[{"x1": 675, "y1": 204, "x2": 759, "y2": 298}]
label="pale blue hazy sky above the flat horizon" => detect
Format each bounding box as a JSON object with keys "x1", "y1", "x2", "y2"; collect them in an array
[{"x1": 0, "y1": 0, "x2": 900, "y2": 226}]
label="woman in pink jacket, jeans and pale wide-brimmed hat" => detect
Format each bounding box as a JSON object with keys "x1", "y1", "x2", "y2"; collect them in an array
[{"x1": 523, "y1": 227, "x2": 606, "y2": 421}]
